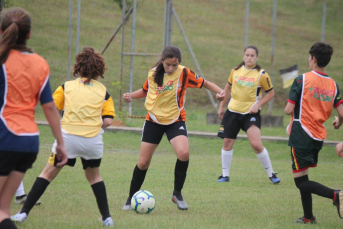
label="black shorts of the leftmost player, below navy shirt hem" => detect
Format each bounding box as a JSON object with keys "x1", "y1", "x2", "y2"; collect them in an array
[{"x1": 0, "y1": 151, "x2": 37, "y2": 176}]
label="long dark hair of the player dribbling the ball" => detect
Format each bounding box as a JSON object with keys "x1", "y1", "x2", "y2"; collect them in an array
[{"x1": 153, "y1": 45, "x2": 182, "y2": 86}]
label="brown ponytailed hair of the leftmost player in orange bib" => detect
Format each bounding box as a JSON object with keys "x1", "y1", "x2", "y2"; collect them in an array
[{"x1": 0, "y1": 8, "x2": 32, "y2": 64}]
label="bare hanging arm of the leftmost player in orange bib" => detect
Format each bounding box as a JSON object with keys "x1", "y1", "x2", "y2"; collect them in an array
[{"x1": 42, "y1": 102, "x2": 68, "y2": 167}]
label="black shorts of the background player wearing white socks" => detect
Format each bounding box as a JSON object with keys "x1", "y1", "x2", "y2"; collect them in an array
[{"x1": 217, "y1": 110, "x2": 261, "y2": 139}]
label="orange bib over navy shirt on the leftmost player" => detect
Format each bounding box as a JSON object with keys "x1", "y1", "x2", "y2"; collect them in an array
[{"x1": 0, "y1": 50, "x2": 53, "y2": 153}]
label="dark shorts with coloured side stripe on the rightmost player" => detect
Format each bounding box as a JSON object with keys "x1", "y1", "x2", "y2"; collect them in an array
[{"x1": 291, "y1": 147, "x2": 320, "y2": 173}]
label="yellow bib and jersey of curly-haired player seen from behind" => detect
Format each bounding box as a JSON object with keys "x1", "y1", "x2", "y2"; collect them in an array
[{"x1": 53, "y1": 78, "x2": 115, "y2": 137}]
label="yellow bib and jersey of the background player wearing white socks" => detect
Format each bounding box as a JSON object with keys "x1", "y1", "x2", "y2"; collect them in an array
[{"x1": 228, "y1": 65, "x2": 273, "y2": 114}]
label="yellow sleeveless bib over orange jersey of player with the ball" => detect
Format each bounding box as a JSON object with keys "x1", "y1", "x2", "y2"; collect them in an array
[{"x1": 145, "y1": 65, "x2": 184, "y2": 125}]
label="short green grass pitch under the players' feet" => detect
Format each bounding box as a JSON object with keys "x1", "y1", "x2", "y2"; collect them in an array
[{"x1": 11, "y1": 126, "x2": 343, "y2": 229}]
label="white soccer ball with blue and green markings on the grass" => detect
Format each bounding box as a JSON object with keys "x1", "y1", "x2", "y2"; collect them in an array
[{"x1": 131, "y1": 190, "x2": 156, "y2": 214}]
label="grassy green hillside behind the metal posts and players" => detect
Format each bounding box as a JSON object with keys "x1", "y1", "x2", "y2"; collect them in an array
[{"x1": 4, "y1": 0, "x2": 343, "y2": 115}]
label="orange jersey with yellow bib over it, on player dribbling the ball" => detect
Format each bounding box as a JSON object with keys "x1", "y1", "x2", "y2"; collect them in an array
[{"x1": 143, "y1": 65, "x2": 204, "y2": 125}]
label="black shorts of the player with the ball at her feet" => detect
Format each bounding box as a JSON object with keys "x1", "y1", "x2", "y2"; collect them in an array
[{"x1": 142, "y1": 121, "x2": 188, "y2": 144}]
